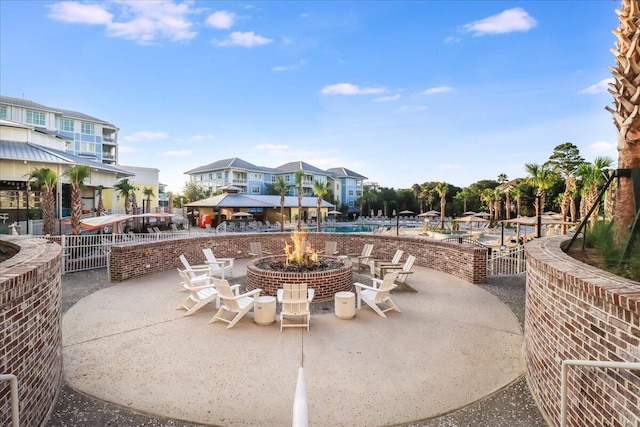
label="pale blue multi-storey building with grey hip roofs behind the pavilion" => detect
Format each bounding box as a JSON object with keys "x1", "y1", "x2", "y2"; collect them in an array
[{"x1": 185, "y1": 157, "x2": 367, "y2": 212}]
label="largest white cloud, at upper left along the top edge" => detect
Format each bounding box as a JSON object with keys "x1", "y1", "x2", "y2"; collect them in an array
[{"x1": 49, "y1": 0, "x2": 197, "y2": 44}]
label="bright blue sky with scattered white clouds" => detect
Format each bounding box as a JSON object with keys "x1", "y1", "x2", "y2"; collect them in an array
[{"x1": 0, "y1": 0, "x2": 620, "y2": 192}]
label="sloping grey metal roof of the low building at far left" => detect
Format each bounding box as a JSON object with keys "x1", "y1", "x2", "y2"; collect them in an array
[{"x1": 0, "y1": 140, "x2": 135, "y2": 178}]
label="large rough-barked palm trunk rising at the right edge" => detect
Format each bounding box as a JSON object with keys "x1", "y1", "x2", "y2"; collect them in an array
[{"x1": 605, "y1": 0, "x2": 640, "y2": 242}]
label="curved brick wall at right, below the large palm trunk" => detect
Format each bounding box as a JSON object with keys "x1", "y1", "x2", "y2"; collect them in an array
[{"x1": 524, "y1": 236, "x2": 640, "y2": 427}]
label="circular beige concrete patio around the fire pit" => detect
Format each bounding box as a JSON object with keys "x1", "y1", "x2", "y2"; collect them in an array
[{"x1": 63, "y1": 260, "x2": 524, "y2": 426}]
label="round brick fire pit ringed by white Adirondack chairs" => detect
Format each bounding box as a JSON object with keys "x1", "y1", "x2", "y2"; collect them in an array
[{"x1": 247, "y1": 255, "x2": 353, "y2": 302}]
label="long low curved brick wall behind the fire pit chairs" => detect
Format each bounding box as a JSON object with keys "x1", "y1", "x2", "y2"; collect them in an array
[{"x1": 110, "y1": 233, "x2": 487, "y2": 284}]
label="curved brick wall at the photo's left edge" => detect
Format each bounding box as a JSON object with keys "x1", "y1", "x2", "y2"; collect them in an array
[{"x1": 0, "y1": 236, "x2": 62, "y2": 426}]
